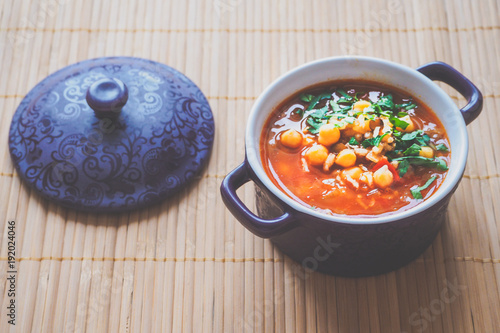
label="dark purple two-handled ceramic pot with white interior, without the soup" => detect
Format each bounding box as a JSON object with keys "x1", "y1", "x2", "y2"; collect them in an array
[{"x1": 221, "y1": 56, "x2": 482, "y2": 277}]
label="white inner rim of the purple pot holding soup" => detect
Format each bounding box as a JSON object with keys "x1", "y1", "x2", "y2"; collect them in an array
[{"x1": 245, "y1": 56, "x2": 468, "y2": 225}]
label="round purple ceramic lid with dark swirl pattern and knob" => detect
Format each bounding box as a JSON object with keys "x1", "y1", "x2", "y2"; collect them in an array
[{"x1": 9, "y1": 57, "x2": 214, "y2": 212}]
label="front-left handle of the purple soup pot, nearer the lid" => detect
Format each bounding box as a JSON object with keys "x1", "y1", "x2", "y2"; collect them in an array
[{"x1": 220, "y1": 160, "x2": 296, "y2": 238}]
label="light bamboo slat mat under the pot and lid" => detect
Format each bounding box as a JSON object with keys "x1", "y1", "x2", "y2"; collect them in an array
[{"x1": 0, "y1": 0, "x2": 500, "y2": 333}]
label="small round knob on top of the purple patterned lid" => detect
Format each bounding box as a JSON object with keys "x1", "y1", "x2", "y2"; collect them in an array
[{"x1": 86, "y1": 78, "x2": 128, "y2": 118}]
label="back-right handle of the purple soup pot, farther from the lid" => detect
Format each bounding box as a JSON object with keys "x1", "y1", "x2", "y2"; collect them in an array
[{"x1": 417, "y1": 61, "x2": 483, "y2": 125}]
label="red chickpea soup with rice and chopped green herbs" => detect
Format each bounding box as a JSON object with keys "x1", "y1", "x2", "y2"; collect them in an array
[{"x1": 260, "y1": 81, "x2": 450, "y2": 216}]
